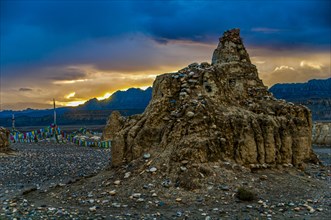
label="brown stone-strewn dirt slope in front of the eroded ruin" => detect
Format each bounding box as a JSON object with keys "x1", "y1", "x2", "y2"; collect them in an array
[{"x1": 0, "y1": 146, "x2": 331, "y2": 219}]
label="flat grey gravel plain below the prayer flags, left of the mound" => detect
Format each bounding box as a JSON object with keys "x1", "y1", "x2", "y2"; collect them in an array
[{"x1": 0, "y1": 142, "x2": 110, "y2": 201}]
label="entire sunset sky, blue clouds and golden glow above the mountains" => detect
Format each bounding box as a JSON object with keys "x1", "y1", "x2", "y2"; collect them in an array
[{"x1": 0, "y1": 0, "x2": 331, "y2": 110}]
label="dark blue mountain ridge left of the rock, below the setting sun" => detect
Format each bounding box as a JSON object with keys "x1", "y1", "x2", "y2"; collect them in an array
[{"x1": 0, "y1": 87, "x2": 152, "y2": 127}]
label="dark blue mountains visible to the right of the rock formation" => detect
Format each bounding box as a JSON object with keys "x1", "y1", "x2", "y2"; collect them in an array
[{"x1": 269, "y1": 78, "x2": 331, "y2": 121}]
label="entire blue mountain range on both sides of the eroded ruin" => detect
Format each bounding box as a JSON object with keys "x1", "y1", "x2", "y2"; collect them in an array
[{"x1": 0, "y1": 78, "x2": 331, "y2": 127}]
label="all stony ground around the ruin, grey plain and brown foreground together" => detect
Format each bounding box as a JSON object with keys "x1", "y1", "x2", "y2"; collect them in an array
[{"x1": 0, "y1": 143, "x2": 331, "y2": 220}]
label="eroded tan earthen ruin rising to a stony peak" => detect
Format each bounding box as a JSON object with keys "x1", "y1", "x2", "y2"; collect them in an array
[{"x1": 105, "y1": 29, "x2": 314, "y2": 169}]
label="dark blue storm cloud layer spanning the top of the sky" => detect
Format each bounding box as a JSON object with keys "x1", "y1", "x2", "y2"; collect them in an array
[{"x1": 1, "y1": 0, "x2": 331, "y2": 69}]
